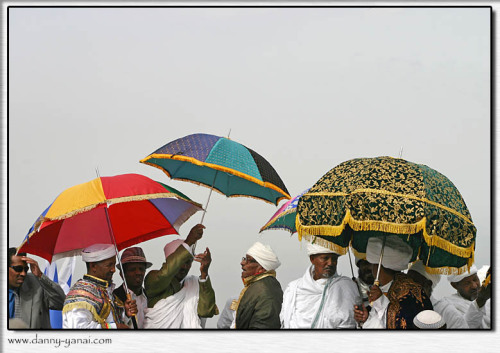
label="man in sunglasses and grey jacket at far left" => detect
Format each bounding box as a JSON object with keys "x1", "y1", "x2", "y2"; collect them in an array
[{"x1": 8, "y1": 248, "x2": 66, "y2": 329}]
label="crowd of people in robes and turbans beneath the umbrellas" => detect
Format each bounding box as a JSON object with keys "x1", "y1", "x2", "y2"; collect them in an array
[{"x1": 8, "y1": 224, "x2": 491, "y2": 329}]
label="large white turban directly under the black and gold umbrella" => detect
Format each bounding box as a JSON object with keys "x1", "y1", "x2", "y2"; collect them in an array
[{"x1": 366, "y1": 235, "x2": 413, "y2": 271}]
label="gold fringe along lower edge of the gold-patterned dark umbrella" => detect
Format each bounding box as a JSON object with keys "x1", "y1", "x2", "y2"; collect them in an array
[{"x1": 295, "y1": 209, "x2": 475, "y2": 265}]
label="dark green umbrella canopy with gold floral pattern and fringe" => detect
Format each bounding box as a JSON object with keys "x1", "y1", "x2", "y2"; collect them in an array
[{"x1": 296, "y1": 157, "x2": 476, "y2": 274}]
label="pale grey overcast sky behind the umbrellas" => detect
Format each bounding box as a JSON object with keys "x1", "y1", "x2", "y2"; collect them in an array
[{"x1": 3, "y1": 3, "x2": 492, "y2": 350}]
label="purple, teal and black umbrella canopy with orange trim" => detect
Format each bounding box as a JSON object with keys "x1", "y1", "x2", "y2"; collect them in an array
[{"x1": 140, "y1": 134, "x2": 290, "y2": 205}]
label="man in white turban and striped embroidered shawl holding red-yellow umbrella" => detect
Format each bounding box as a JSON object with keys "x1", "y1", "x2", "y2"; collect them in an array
[{"x1": 63, "y1": 244, "x2": 137, "y2": 329}]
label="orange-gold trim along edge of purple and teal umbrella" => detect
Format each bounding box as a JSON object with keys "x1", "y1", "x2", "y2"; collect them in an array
[{"x1": 139, "y1": 154, "x2": 292, "y2": 204}]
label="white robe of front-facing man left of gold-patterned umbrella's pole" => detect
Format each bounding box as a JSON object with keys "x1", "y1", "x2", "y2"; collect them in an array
[{"x1": 280, "y1": 265, "x2": 361, "y2": 329}]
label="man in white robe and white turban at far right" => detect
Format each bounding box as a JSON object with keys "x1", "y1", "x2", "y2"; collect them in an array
[{"x1": 434, "y1": 265, "x2": 491, "y2": 329}]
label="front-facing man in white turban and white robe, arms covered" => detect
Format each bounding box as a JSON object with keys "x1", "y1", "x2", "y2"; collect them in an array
[{"x1": 280, "y1": 244, "x2": 361, "y2": 329}]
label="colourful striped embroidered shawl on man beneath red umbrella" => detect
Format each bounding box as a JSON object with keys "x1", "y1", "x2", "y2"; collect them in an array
[{"x1": 63, "y1": 275, "x2": 125, "y2": 328}]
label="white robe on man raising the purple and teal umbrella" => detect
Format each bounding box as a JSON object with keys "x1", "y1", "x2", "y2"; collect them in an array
[{"x1": 144, "y1": 276, "x2": 202, "y2": 329}]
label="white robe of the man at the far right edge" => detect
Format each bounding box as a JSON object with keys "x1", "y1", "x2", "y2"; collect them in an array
[{"x1": 434, "y1": 292, "x2": 491, "y2": 329}]
